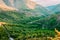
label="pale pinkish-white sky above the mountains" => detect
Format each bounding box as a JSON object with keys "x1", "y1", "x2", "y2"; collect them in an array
[{"x1": 32, "y1": 0, "x2": 60, "y2": 7}]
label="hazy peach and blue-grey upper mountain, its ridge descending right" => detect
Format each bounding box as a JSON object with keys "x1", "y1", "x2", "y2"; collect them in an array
[{"x1": 0, "y1": 0, "x2": 53, "y2": 16}]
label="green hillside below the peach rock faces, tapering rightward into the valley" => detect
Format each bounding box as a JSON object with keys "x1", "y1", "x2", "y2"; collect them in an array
[{"x1": 0, "y1": 9, "x2": 48, "y2": 24}]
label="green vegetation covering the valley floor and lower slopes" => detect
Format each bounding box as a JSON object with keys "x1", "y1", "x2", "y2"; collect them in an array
[{"x1": 0, "y1": 10, "x2": 60, "y2": 40}]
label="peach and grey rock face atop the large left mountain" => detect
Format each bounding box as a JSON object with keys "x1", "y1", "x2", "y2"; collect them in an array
[{"x1": 0, "y1": 0, "x2": 36, "y2": 10}]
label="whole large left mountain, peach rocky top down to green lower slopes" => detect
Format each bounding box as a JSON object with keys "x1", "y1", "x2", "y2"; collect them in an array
[{"x1": 0, "y1": 0, "x2": 53, "y2": 23}]
